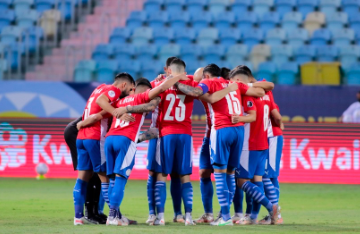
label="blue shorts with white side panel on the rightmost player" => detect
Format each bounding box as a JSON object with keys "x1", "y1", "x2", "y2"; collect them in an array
[{"x1": 264, "y1": 136, "x2": 284, "y2": 178}]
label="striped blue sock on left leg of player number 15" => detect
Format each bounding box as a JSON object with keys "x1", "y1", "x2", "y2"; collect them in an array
[{"x1": 214, "y1": 172, "x2": 231, "y2": 221}]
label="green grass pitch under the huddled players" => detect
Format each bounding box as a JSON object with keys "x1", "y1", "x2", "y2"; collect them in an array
[{"x1": 0, "y1": 178, "x2": 360, "y2": 234}]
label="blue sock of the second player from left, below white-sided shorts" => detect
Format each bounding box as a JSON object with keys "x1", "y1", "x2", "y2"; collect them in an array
[{"x1": 109, "y1": 176, "x2": 127, "y2": 218}]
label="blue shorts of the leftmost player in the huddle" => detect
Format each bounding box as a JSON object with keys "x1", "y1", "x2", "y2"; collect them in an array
[{"x1": 76, "y1": 139, "x2": 106, "y2": 172}]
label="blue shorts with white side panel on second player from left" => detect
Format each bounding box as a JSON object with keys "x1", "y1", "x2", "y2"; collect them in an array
[{"x1": 105, "y1": 136, "x2": 136, "y2": 179}]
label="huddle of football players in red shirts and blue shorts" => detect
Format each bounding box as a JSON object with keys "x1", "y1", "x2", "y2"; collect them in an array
[{"x1": 73, "y1": 57, "x2": 283, "y2": 226}]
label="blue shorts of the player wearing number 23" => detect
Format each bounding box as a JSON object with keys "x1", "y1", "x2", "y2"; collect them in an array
[{"x1": 156, "y1": 134, "x2": 193, "y2": 175}]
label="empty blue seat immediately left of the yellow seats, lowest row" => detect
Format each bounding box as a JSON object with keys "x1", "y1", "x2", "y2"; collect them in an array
[{"x1": 276, "y1": 62, "x2": 299, "y2": 85}]
